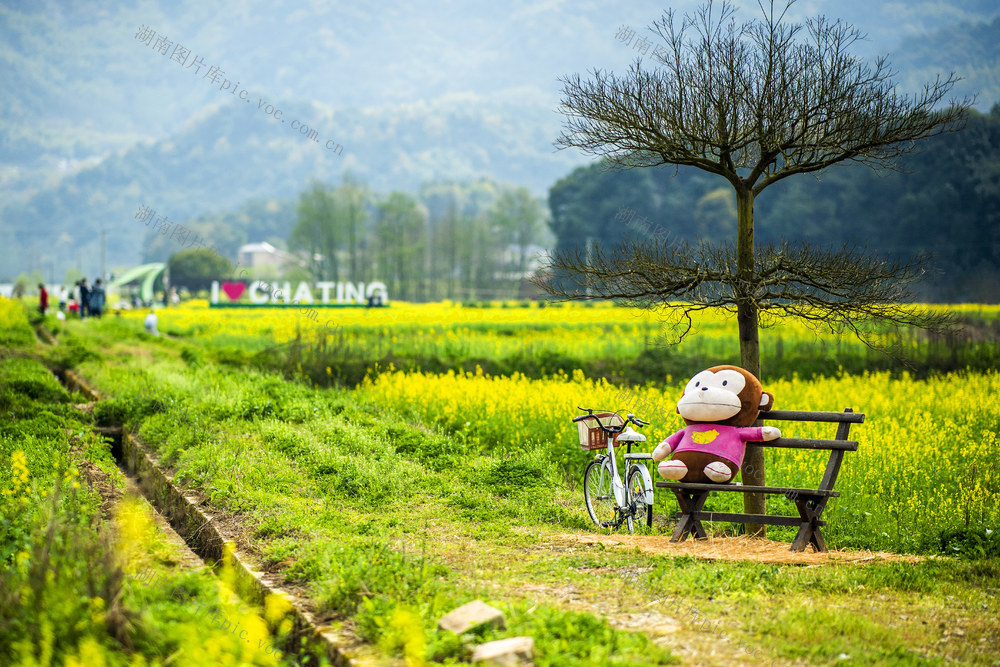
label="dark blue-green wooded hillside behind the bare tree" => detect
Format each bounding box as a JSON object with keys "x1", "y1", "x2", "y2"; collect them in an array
[{"x1": 549, "y1": 104, "x2": 1000, "y2": 303}]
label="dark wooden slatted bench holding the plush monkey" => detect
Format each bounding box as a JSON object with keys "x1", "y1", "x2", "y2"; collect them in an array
[{"x1": 656, "y1": 408, "x2": 865, "y2": 551}]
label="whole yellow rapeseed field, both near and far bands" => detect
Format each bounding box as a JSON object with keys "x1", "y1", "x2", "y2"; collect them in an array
[{"x1": 48, "y1": 301, "x2": 1000, "y2": 552}]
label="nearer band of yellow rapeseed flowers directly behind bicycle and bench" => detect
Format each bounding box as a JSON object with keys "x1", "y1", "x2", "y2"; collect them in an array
[{"x1": 359, "y1": 362, "x2": 1000, "y2": 551}]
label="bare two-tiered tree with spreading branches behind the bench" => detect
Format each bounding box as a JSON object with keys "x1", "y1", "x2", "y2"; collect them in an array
[{"x1": 540, "y1": 0, "x2": 972, "y2": 533}]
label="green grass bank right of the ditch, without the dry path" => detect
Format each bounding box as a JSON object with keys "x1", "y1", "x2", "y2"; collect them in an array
[{"x1": 64, "y1": 322, "x2": 671, "y2": 665}]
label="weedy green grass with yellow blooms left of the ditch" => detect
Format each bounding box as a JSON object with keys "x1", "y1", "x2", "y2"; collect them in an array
[{"x1": 0, "y1": 306, "x2": 328, "y2": 667}]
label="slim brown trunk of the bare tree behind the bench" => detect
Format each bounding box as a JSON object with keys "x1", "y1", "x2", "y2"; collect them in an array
[{"x1": 736, "y1": 185, "x2": 767, "y2": 537}]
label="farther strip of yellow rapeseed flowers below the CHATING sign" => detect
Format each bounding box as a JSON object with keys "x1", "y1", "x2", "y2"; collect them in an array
[{"x1": 113, "y1": 301, "x2": 1000, "y2": 386}]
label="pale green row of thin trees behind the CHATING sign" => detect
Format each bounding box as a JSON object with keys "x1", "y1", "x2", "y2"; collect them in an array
[{"x1": 170, "y1": 174, "x2": 551, "y2": 301}]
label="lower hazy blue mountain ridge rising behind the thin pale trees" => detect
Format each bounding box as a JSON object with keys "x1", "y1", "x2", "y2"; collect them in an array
[{"x1": 0, "y1": 95, "x2": 580, "y2": 278}]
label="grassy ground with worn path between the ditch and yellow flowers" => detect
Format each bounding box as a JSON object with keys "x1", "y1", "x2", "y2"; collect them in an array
[{"x1": 29, "y1": 314, "x2": 1000, "y2": 665}]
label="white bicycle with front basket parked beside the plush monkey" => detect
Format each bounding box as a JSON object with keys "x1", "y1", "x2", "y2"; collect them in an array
[{"x1": 573, "y1": 408, "x2": 653, "y2": 533}]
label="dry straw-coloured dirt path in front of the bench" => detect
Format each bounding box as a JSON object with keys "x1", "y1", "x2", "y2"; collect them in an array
[{"x1": 422, "y1": 521, "x2": 936, "y2": 667}]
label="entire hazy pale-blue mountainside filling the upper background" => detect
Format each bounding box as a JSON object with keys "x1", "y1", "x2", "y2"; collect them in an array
[{"x1": 0, "y1": 0, "x2": 1000, "y2": 280}]
